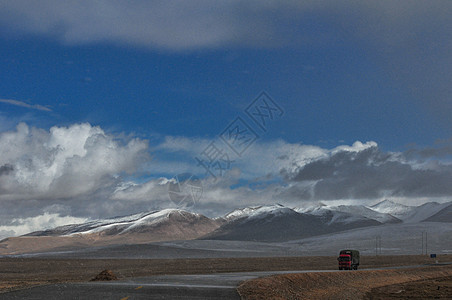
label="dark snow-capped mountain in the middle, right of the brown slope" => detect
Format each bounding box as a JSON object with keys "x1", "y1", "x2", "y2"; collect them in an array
[{"x1": 203, "y1": 204, "x2": 382, "y2": 242}]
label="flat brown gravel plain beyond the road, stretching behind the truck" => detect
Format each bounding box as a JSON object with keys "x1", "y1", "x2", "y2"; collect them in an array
[{"x1": 0, "y1": 255, "x2": 452, "y2": 293}]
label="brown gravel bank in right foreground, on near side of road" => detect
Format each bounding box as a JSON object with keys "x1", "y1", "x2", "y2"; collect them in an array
[{"x1": 238, "y1": 265, "x2": 452, "y2": 299}]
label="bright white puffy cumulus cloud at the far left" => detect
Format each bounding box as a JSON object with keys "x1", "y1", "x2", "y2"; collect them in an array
[{"x1": 0, "y1": 123, "x2": 148, "y2": 201}]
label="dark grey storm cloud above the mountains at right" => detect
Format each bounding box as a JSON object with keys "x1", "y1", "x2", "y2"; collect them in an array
[{"x1": 282, "y1": 147, "x2": 452, "y2": 200}]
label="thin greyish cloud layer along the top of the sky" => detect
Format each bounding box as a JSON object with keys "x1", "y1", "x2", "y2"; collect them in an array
[{"x1": 0, "y1": 0, "x2": 450, "y2": 50}]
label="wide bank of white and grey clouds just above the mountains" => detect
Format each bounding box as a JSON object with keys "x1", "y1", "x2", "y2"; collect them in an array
[{"x1": 0, "y1": 123, "x2": 452, "y2": 237}]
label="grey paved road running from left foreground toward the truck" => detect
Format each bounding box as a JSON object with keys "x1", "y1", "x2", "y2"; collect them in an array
[{"x1": 0, "y1": 263, "x2": 450, "y2": 300}]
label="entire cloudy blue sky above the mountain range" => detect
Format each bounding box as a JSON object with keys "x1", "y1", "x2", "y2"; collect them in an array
[{"x1": 0, "y1": 0, "x2": 452, "y2": 238}]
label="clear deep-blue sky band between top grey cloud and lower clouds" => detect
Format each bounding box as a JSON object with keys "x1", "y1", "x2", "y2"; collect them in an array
[{"x1": 1, "y1": 37, "x2": 450, "y2": 150}]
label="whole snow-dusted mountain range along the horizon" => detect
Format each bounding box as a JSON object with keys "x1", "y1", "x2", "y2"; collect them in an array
[{"x1": 0, "y1": 200, "x2": 452, "y2": 255}]
